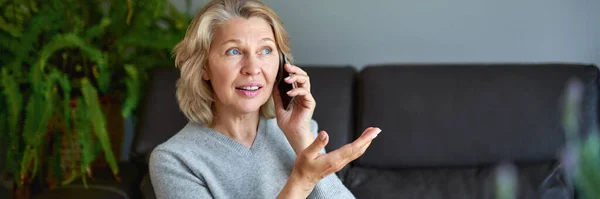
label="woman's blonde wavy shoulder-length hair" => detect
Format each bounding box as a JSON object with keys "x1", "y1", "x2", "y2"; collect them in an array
[{"x1": 173, "y1": 0, "x2": 293, "y2": 125}]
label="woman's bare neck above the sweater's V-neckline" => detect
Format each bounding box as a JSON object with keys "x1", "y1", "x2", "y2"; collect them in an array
[{"x1": 211, "y1": 105, "x2": 260, "y2": 148}]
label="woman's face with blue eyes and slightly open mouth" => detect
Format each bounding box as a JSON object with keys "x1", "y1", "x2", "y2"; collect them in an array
[{"x1": 202, "y1": 17, "x2": 279, "y2": 114}]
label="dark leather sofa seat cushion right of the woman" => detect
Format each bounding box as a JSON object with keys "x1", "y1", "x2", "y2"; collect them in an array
[{"x1": 344, "y1": 163, "x2": 554, "y2": 199}]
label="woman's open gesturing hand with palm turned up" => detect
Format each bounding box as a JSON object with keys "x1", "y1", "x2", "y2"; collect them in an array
[{"x1": 278, "y1": 127, "x2": 381, "y2": 198}]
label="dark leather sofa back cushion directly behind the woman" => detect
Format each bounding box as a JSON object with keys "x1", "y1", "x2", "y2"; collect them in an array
[{"x1": 132, "y1": 65, "x2": 357, "y2": 162}]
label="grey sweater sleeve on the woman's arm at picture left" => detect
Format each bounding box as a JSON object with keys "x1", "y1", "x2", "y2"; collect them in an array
[{"x1": 149, "y1": 150, "x2": 213, "y2": 199}]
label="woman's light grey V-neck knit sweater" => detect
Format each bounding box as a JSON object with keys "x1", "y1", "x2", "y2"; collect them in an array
[{"x1": 150, "y1": 118, "x2": 354, "y2": 199}]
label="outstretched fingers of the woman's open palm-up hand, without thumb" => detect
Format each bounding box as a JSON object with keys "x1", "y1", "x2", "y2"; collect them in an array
[{"x1": 329, "y1": 128, "x2": 381, "y2": 162}]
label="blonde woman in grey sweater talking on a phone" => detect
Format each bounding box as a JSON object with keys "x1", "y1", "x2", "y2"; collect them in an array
[{"x1": 150, "y1": 0, "x2": 380, "y2": 198}]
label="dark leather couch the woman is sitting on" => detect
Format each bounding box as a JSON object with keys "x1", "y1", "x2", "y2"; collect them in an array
[{"x1": 34, "y1": 63, "x2": 599, "y2": 199}]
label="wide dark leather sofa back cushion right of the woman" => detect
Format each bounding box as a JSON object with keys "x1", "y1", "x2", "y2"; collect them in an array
[{"x1": 355, "y1": 64, "x2": 598, "y2": 168}]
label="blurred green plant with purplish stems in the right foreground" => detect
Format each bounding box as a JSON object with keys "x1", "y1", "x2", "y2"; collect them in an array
[{"x1": 495, "y1": 78, "x2": 600, "y2": 199}]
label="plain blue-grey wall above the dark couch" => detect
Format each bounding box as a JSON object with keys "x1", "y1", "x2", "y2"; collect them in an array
[{"x1": 172, "y1": 0, "x2": 600, "y2": 68}]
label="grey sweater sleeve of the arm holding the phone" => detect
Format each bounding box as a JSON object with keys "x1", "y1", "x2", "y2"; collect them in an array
[{"x1": 308, "y1": 120, "x2": 355, "y2": 199}]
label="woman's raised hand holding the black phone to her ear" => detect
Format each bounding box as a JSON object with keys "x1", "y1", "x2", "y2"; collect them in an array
[{"x1": 273, "y1": 64, "x2": 316, "y2": 154}]
